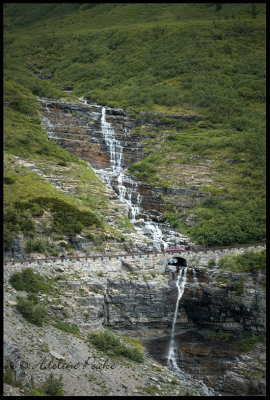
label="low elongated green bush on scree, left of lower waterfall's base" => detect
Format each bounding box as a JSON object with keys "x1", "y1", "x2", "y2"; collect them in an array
[{"x1": 88, "y1": 331, "x2": 144, "y2": 363}]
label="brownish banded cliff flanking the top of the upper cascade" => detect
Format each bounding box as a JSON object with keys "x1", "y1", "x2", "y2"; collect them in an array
[{"x1": 40, "y1": 99, "x2": 144, "y2": 168}]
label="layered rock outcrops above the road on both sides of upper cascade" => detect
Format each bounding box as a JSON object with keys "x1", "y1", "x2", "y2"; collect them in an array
[{"x1": 40, "y1": 98, "x2": 205, "y2": 228}]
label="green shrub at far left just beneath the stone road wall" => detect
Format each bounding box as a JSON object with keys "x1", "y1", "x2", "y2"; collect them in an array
[{"x1": 9, "y1": 268, "x2": 51, "y2": 293}]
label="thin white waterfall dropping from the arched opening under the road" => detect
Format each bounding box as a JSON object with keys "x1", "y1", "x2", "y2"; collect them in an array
[{"x1": 167, "y1": 267, "x2": 187, "y2": 373}]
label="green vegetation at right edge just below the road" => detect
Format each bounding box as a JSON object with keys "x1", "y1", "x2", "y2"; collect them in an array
[{"x1": 218, "y1": 250, "x2": 266, "y2": 272}]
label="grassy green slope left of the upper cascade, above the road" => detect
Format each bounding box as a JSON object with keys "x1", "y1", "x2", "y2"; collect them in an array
[{"x1": 4, "y1": 81, "x2": 128, "y2": 256}]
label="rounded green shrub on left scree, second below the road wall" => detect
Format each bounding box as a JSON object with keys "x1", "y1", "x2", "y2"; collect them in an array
[{"x1": 16, "y1": 295, "x2": 47, "y2": 326}]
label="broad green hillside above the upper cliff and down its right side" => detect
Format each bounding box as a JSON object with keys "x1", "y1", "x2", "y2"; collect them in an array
[{"x1": 4, "y1": 3, "x2": 266, "y2": 244}]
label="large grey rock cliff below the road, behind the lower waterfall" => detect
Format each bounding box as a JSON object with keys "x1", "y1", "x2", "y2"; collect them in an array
[{"x1": 5, "y1": 247, "x2": 266, "y2": 395}]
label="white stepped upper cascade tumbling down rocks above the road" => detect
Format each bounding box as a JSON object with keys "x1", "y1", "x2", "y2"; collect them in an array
[{"x1": 101, "y1": 107, "x2": 168, "y2": 251}]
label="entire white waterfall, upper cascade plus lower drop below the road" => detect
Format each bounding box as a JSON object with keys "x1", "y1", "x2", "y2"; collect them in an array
[{"x1": 39, "y1": 98, "x2": 212, "y2": 395}]
